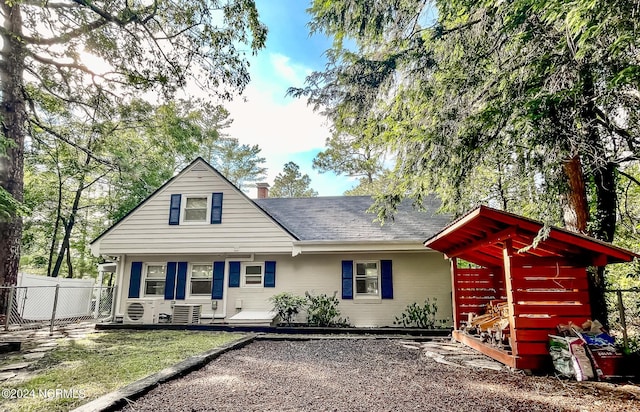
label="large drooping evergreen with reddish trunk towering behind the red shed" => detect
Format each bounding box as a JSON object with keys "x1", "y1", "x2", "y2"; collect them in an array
[{"x1": 304, "y1": 0, "x2": 640, "y2": 320}]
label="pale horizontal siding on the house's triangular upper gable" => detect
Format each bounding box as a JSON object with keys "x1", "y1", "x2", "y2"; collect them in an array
[{"x1": 92, "y1": 162, "x2": 293, "y2": 255}]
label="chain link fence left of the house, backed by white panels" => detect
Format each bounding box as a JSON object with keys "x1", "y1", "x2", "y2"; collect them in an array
[{"x1": 0, "y1": 285, "x2": 114, "y2": 331}]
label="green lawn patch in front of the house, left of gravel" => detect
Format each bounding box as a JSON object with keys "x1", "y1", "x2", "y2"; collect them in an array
[{"x1": 0, "y1": 330, "x2": 241, "y2": 411}]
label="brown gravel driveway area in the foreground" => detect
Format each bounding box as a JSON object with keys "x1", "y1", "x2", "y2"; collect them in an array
[{"x1": 123, "y1": 339, "x2": 640, "y2": 411}]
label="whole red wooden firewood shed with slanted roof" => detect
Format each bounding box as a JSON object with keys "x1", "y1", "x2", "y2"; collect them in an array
[{"x1": 424, "y1": 206, "x2": 638, "y2": 369}]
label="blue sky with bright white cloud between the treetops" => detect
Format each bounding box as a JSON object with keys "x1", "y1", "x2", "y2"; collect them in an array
[{"x1": 225, "y1": 0, "x2": 355, "y2": 196}]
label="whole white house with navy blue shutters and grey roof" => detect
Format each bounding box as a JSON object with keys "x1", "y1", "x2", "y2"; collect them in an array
[{"x1": 91, "y1": 158, "x2": 452, "y2": 327}]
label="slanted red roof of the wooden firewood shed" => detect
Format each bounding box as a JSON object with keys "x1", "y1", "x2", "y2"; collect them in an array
[{"x1": 424, "y1": 206, "x2": 639, "y2": 267}]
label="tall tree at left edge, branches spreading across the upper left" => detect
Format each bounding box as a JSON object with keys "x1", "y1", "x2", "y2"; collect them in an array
[{"x1": 0, "y1": 0, "x2": 266, "y2": 290}]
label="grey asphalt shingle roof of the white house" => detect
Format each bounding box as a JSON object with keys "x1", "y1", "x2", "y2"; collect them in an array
[{"x1": 254, "y1": 196, "x2": 452, "y2": 242}]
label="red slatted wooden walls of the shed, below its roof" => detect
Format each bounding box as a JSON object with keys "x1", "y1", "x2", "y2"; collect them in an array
[{"x1": 452, "y1": 258, "x2": 591, "y2": 369}]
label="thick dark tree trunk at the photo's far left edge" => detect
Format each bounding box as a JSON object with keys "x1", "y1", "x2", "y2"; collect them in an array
[{"x1": 0, "y1": 1, "x2": 28, "y2": 292}]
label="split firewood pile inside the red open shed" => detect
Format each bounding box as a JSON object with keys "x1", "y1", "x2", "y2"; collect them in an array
[{"x1": 464, "y1": 299, "x2": 509, "y2": 349}]
